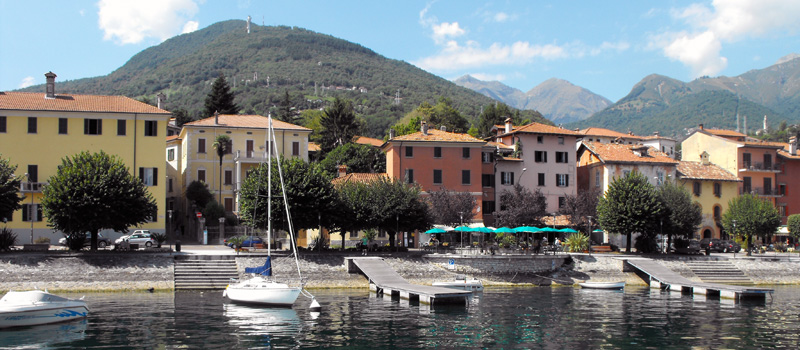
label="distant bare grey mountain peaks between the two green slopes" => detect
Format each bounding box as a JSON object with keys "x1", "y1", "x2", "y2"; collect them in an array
[{"x1": 453, "y1": 75, "x2": 612, "y2": 124}]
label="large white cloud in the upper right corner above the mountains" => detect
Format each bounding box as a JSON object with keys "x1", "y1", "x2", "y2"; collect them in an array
[{"x1": 650, "y1": 0, "x2": 800, "y2": 77}]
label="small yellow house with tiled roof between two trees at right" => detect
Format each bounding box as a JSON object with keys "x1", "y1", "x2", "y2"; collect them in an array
[{"x1": 678, "y1": 157, "x2": 741, "y2": 239}]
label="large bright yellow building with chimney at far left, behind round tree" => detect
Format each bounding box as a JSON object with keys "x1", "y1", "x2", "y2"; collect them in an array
[{"x1": 0, "y1": 72, "x2": 170, "y2": 244}]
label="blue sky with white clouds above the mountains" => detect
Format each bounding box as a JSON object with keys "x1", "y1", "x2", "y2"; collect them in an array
[{"x1": 0, "y1": 0, "x2": 800, "y2": 101}]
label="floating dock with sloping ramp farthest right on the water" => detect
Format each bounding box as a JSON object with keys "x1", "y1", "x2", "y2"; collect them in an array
[{"x1": 625, "y1": 258, "x2": 774, "y2": 300}]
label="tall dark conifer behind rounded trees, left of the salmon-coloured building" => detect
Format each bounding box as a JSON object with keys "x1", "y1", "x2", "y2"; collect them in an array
[{"x1": 319, "y1": 97, "x2": 361, "y2": 153}]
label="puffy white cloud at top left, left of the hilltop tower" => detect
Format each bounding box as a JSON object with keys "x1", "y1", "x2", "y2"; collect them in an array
[{"x1": 97, "y1": 0, "x2": 198, "y2": 45}]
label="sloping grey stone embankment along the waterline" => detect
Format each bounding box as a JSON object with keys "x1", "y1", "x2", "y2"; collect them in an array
[{"x1": 0, "y1": 253, "x2": 800, "y2": 292}]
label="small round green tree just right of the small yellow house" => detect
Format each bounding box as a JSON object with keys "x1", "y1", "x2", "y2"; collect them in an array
[{"x1": 722, "y1": 194, "x2": 781, "y2": 255}]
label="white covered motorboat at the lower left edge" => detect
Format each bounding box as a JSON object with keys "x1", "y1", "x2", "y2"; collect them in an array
[{"x1": 0, "y1": 290, "x2": 89, "y2": 328}]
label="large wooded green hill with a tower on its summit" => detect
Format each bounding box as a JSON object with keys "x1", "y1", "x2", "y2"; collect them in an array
[{"x1": 18, "y1": 20, "x2": 549, "y2": 137}]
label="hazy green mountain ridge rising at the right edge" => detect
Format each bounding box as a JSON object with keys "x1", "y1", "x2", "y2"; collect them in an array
[{"x1": 569, "y1": 54, "x2": 800, "y2": 138}]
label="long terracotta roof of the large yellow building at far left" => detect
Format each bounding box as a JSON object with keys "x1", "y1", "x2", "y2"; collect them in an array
[{"x1": 0, "y1": 91, "x2": 170, "y2": 115}]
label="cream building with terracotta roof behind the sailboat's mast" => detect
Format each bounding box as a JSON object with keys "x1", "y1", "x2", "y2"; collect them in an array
[{"x1": 173, "y1": 114, "x2": 311, "y2": 232}]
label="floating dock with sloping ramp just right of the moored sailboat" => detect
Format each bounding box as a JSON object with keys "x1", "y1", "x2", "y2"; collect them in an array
[{"x1": 345, "y1": 257, "x2": 472, "y2": 305}]
